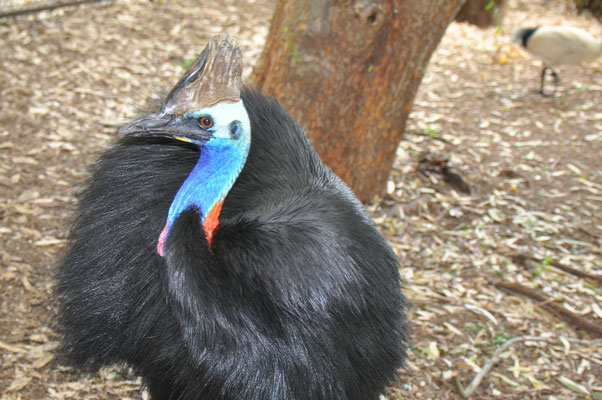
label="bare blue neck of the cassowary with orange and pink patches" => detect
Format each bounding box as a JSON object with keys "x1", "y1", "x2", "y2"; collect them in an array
[{"x1": 157, "y1": 139, "x2": 248, "y2": 257}]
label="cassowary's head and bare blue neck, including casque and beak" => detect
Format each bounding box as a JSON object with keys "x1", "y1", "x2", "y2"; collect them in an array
[{"x1": 119, "y1": 35, "x2": 251, "y2": 257}]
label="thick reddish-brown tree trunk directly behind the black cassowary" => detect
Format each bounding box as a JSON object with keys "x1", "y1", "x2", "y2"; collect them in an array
[{"x1": 252, "y1": 0, "x2": 463, "y2": 201}]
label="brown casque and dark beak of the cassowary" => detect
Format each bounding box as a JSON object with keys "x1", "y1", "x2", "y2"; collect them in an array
[{"x1": 119, "y1": 34, "x2": 242, "y2": 141}]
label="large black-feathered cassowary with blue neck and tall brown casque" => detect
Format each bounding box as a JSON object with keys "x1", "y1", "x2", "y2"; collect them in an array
[{"x1": 56, "y1": 35, "x2": 408, "y2": 400}]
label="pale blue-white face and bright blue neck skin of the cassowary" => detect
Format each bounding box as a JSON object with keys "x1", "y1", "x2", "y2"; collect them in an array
[{"x1": 157, "y1": 102, "x2": 251, "y2": 256}]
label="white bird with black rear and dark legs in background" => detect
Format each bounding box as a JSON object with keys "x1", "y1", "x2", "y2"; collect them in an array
[{"x1": 514, "y1": 26, "x2": 602, "y2": 96}]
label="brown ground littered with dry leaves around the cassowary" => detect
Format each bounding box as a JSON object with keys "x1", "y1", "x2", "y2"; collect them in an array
[{"x1": 0, "y1": 0, "x2": 602, "y2": 400}]
